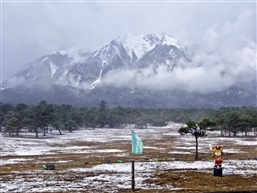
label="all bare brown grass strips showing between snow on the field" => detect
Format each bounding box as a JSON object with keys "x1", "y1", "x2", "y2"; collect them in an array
[{"x1": 0, "y1": 132, "x2": 257, "y2": 193}]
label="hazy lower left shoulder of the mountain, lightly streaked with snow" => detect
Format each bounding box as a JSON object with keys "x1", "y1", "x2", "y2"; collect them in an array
[{"x1": 2, "y1": 48, "x2": 92, "y2": 89}]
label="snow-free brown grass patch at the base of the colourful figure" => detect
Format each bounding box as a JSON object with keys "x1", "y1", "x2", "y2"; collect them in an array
[{"x1": 146, "y1": 170, "x2": 257, "y2": 192}]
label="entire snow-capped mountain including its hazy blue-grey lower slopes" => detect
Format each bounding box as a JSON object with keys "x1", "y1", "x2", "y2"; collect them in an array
[{"x1": 1, "y1": 33, "x2": 256, "y2": 108}]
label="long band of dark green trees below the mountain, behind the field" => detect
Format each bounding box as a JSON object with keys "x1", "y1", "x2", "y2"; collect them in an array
[{"x1": 0, "y1": 101, "x2": 257, "y2": 137}]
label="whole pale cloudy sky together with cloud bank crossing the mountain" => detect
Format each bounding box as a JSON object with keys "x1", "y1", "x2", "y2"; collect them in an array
[{"x1": 1, "y1": 2, "x2": 256, "y2": 92}]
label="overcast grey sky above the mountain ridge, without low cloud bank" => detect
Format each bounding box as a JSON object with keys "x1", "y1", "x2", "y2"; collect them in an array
[{"x1": 1, "y1": 0, "x2": 256, "y2": 84}]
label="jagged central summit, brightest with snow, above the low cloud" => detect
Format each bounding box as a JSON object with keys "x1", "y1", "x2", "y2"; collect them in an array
[{"x1": 74, "y1": 33, "x2": 187, "y2": 89}]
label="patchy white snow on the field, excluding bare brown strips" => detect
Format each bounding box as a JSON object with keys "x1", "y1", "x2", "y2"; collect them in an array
[{"x1": 0, "y1": 124, "x2": 257, "y2": 193}]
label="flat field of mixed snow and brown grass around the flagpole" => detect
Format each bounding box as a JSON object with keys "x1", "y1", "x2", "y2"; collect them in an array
[{"x1": 0, "y1": 124, "x2": 257, "y2": 193}]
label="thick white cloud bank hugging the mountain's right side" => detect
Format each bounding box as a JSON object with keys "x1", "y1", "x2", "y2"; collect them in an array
[{"x1": 102, "y1": 11, "x2": 257, "y2": 93}]
